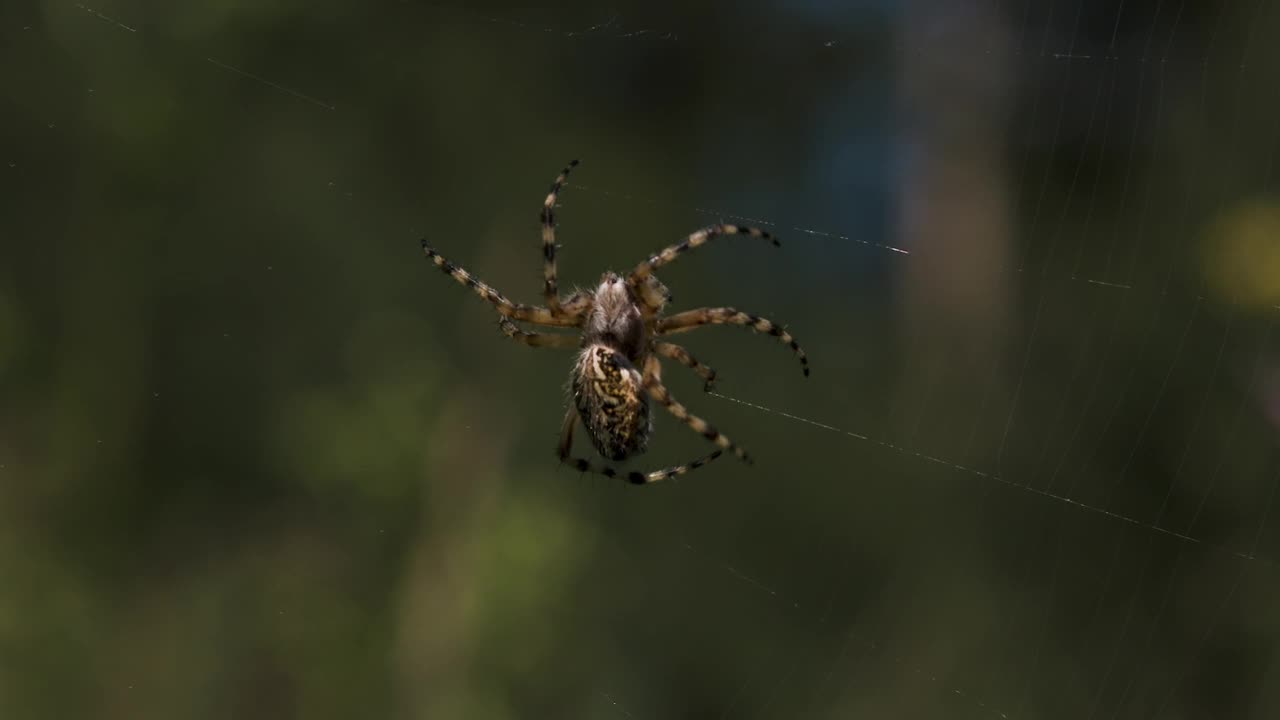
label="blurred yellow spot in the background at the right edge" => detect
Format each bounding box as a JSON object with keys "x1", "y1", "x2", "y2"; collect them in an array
[{"x1": 1204, "y1": 200, "x2": 1280, "y2": 307}]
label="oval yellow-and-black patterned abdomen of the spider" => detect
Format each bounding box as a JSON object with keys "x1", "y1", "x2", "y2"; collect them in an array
[{"x1": 573, "y1": 345, "x2": 653, "y2": 460}]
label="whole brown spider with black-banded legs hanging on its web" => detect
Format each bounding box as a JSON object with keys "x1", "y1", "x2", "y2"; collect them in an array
[{"x1": 422, "y1": 160, "x2": 809, "y2": 484}]
